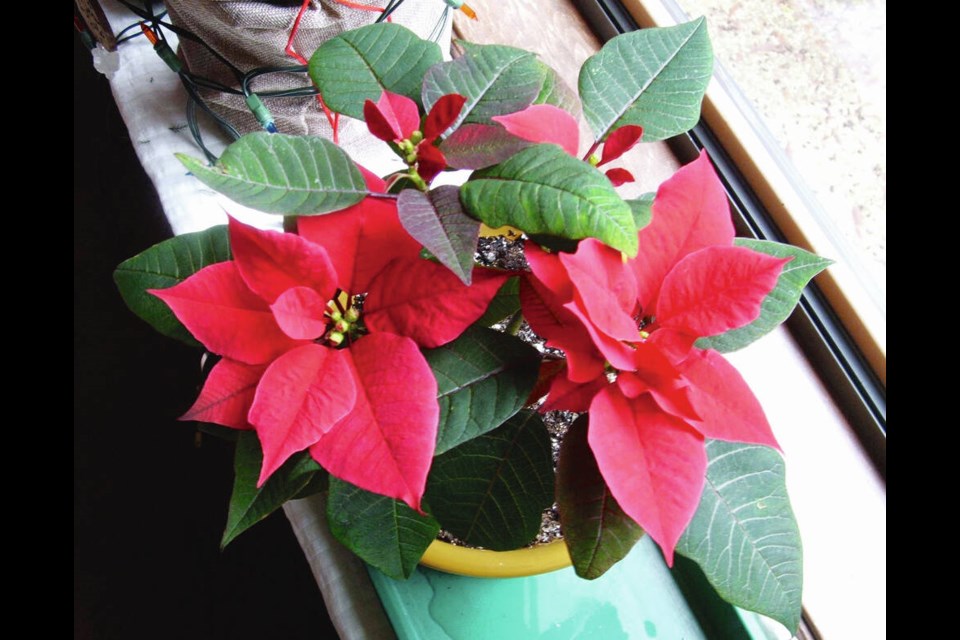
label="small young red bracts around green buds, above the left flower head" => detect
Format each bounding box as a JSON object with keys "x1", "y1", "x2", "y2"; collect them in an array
[{"x1": 363, "y1": 91, "x2": 467, "y2": 182}]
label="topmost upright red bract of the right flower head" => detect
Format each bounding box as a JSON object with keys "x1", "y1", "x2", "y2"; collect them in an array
[{"x1": 633, "y1": 152, "x2": 733, "y2": 313}]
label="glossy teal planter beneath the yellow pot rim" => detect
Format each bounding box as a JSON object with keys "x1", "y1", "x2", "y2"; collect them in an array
[{"x1": 369, "y1": 536, "x2": 707, "y2": 640}]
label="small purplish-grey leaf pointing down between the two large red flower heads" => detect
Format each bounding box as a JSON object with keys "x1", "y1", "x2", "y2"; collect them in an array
[{"x1": 397, "y1": 185, "x2": 480, "y2": 286}]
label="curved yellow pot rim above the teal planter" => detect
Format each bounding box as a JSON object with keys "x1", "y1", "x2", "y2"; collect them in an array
[{"x1": 420, "y1": 540, "x2": 571, "y2": 578}]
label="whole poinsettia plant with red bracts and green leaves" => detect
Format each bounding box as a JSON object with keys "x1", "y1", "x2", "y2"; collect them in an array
[{"x1": 116, "y1": 19, "x2": 827, "y2": 629}]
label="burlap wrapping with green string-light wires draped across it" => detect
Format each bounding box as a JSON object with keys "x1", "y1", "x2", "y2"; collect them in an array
[{"x1": 166, "y1": 0, "x2": 450, "y2": 138}]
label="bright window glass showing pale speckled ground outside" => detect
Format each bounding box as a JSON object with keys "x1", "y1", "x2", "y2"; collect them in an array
[{"x1": 666, "y1": 0, "x2": 887, "y2": 332}]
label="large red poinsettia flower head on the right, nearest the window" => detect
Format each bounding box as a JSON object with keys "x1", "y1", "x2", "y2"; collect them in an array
[{"x1": 521, "y1": 154, "x2": 787, "y2": 563}]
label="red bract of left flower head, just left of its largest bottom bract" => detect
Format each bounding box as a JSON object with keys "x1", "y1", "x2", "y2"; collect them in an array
[{"x1": 250, "y1": 344, "x2": 357, "y2": 487}]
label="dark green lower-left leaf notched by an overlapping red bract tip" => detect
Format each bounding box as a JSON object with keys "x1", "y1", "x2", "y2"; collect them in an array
[{"x1": 220, "y1": 431, "x2": 322, "y2": 549}]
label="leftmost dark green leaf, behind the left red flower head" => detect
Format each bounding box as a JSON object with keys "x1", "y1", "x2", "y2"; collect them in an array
[{"x1": 113, "y1": 225, "x2": 230, "y2": 346}]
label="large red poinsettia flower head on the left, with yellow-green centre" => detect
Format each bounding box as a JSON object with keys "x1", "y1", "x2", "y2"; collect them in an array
[{"x1": 151, "y1": 174, "x2": 506, "y2": 510}]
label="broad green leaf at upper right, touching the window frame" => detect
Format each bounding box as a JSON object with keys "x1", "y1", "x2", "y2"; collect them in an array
[{"x1": 579, "y1": 17, "x2": 713, "y2": 142}]
